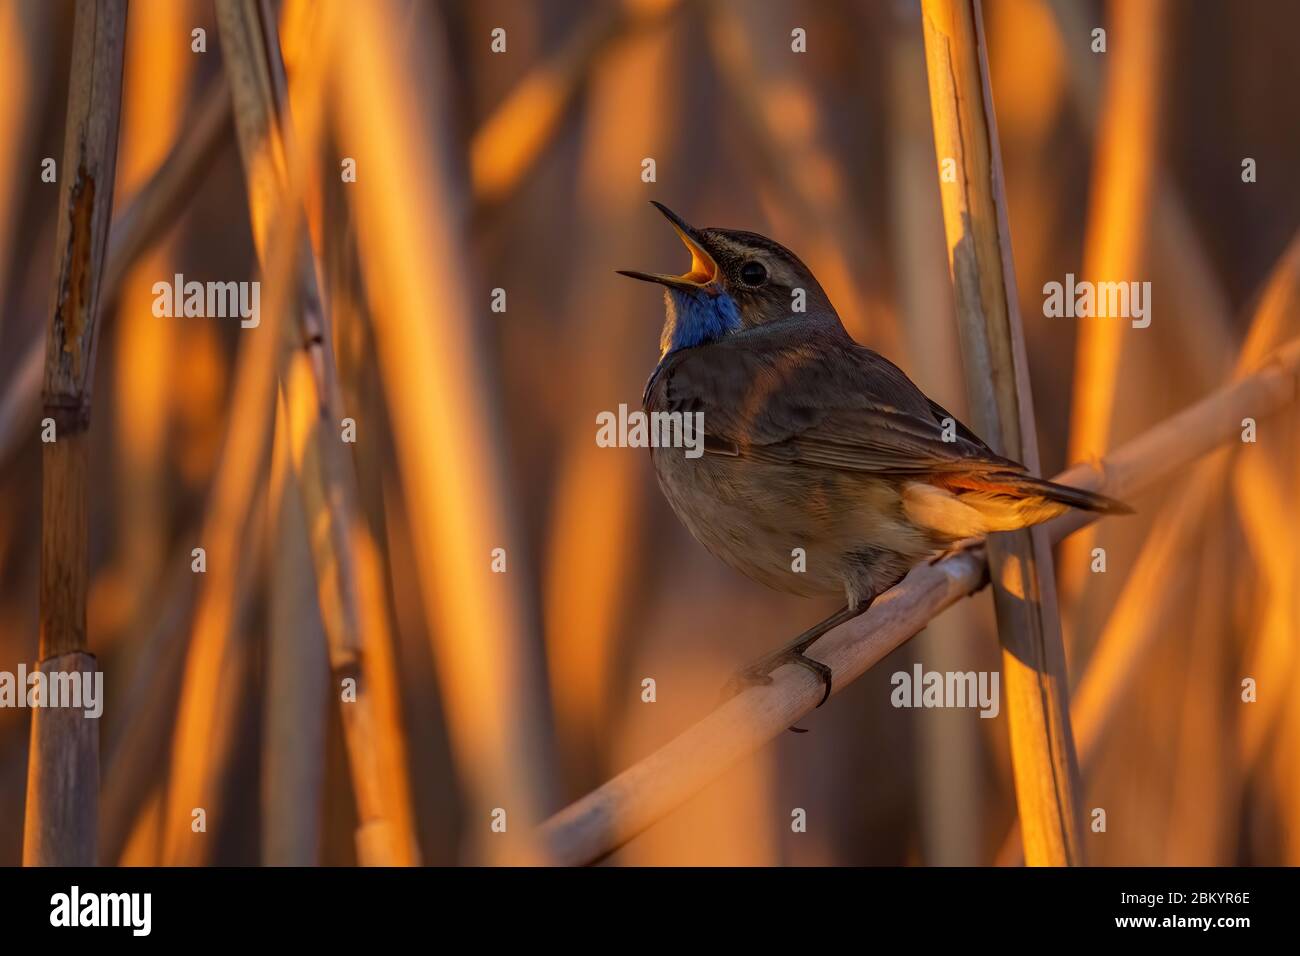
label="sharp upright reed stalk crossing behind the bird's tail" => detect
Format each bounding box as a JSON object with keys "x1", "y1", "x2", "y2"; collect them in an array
[{"x1": 922, "y1": 0, "x2": 1083, "y2": 866}]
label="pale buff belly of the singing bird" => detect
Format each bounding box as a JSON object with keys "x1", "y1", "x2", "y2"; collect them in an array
[{"x1": 653, "y1": 447, "x2": 935, "y2": 604}]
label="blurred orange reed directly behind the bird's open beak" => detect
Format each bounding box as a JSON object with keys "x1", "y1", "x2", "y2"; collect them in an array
[{"x1": 535, "y1": 1, "x2": 690, "y2": 788}]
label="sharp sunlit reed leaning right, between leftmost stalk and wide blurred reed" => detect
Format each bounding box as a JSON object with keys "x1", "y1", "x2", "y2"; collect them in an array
[{"x1": 217, "y1": 0, "x2": 419, "y2": 866}]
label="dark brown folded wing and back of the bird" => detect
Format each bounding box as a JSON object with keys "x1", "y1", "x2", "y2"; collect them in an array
[{"x1": 646, "y1": 328, "x2": 1022, "y2": 476}]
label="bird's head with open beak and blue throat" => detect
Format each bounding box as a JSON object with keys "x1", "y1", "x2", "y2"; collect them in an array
[{"x1": 619, "y1": 203, "x2": 839, "y2": 355}]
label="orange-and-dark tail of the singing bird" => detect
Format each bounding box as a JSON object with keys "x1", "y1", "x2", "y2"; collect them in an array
[{"x1": 902, "y1": 471, "x2": 1132, "y2": 537}]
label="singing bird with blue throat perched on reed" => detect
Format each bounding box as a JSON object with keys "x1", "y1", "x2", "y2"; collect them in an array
[{"x1": 620, "y1": 203, "x2": 1130, "y2": 706}]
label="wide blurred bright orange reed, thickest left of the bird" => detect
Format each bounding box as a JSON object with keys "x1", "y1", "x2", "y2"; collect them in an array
[{"x1": 330, "y1": 1, "x2": 553, "y2": 858}]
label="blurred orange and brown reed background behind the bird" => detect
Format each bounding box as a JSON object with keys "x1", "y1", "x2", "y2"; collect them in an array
[{"x1": 0, "y1": 0, "x2": 1300, "y2": 865}]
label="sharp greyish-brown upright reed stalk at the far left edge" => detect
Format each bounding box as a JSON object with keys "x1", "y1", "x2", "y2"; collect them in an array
[{"x1": 22, "y1": 0, "x2": 126, "y2": 866}]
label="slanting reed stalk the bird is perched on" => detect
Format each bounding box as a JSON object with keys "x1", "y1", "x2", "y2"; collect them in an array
[{"x1": 538, "y1": 339, "x2": 1300, "y2": 865}]
